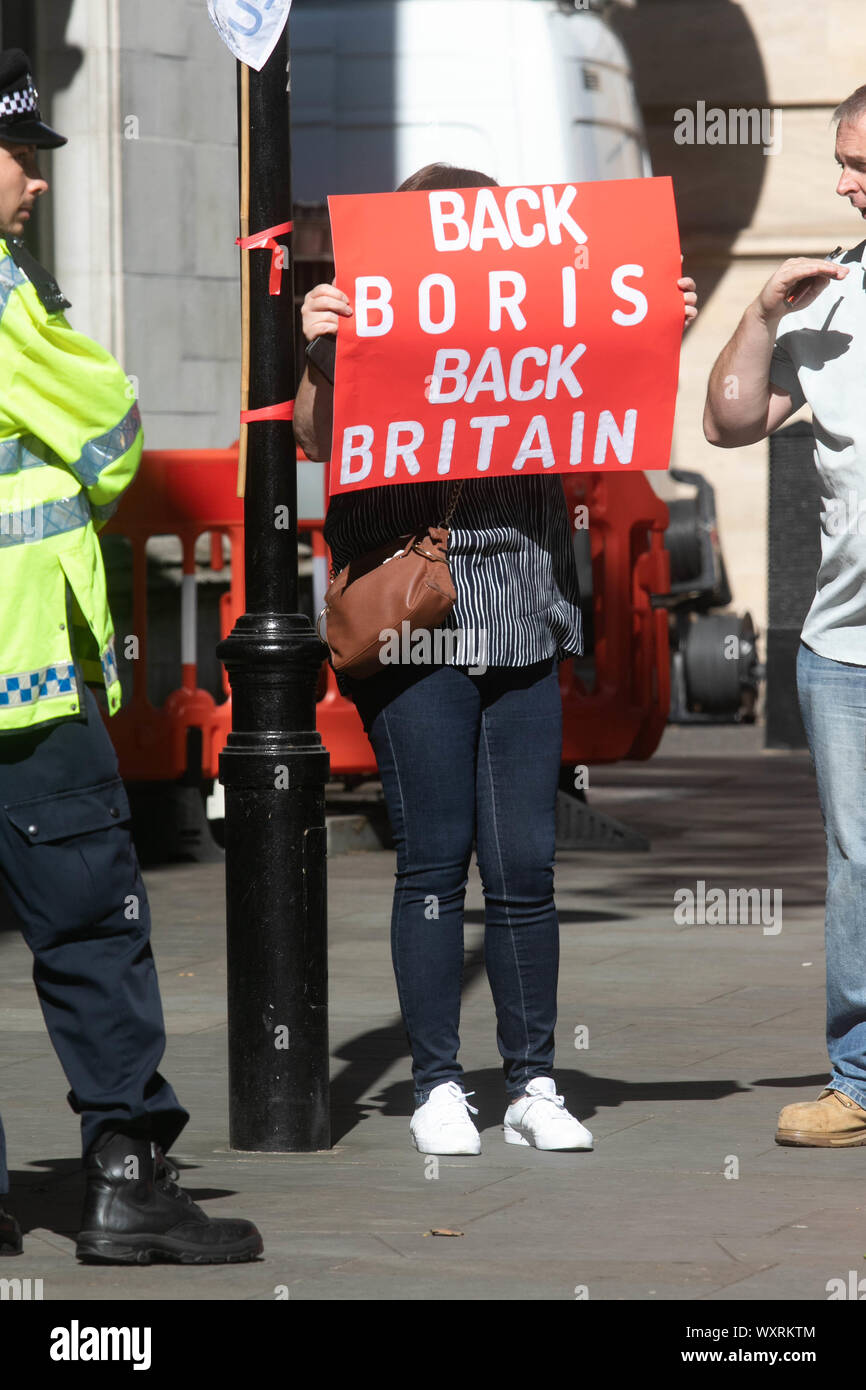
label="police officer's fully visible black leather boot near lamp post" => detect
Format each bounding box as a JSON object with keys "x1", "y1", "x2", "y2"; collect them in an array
[{"x1": 75, "y1": 1131, "x2": 263, "y2": 1265}]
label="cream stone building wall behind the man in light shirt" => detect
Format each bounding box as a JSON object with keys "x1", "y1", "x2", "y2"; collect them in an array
[{"x1": 614, "y1": 0, "x2": 866, "y2": 628}]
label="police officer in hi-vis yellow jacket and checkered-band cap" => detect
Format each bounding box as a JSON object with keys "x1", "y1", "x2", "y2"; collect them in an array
[{"x1": 0, "y1": 49, "x2": 263, "y2": 1264}]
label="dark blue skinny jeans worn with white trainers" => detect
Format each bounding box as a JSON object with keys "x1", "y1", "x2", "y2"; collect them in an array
[{"x1": 346, "y1": 660, "x2": 562, "y2": 1105}]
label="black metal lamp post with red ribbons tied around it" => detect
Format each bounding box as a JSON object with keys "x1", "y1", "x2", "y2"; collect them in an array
[{"x1": 217, "y1": 29, "x2": 331, "y2": 1152}]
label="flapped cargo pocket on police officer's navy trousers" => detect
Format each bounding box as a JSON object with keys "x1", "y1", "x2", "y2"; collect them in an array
[{"x1": 3, "y1": 777, "x2": 138, "y2": 938}]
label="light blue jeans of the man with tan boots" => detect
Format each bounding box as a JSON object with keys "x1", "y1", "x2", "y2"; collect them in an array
[{"x1": 796, "y1": 642, "x2": 866, "y2": 1108}]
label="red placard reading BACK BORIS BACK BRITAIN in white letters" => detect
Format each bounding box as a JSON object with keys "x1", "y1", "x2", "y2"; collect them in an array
[{"x1": 328, "y1": 178, "x2": 684, "y2": 493}]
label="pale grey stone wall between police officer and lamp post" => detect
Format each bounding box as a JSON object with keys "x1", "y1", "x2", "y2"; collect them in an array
[{"x1": 38, "y1": 0, "x2": 239, "y2": 449}]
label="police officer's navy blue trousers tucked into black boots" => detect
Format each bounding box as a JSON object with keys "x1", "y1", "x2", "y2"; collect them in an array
[{"x1": 0, "y1": 691, "x2": 189, "y2": 1195}]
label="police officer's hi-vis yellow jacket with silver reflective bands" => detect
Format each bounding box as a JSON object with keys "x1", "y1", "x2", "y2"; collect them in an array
[{"x1": 0, "y1": 239, "x2": 143, "y2": 735}]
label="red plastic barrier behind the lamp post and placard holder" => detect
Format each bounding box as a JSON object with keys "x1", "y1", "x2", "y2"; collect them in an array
[{"x1": 106, "y1": 448, "x2": 670, "y2": 781}]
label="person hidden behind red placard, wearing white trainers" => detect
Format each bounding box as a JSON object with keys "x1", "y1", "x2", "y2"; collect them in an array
[{"x1": 295, "y1": 164, "x2": 696, "y2": 1154}]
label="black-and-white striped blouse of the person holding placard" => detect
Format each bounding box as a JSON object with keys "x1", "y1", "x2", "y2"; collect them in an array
[{"x1": 319, "y1": 474, "x2": 582, "y2": 666}]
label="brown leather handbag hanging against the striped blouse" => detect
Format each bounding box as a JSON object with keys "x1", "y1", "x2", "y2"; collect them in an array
[{"x1": 316, "y1": 481, "x2": 463, "y2": 680}]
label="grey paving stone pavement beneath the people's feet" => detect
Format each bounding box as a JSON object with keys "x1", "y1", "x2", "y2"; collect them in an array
[{"x1": 0, "y1": 728, "x2": 866, "y2": 1302}]
